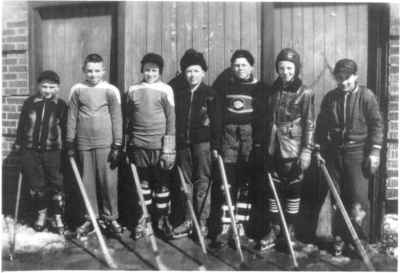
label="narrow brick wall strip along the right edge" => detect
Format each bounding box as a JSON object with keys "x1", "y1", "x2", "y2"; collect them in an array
[{"x1": 386, "y1": 4, "x2": 400, "y2": 203}]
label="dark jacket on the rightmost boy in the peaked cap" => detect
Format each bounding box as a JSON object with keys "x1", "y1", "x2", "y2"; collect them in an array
[{"x1": 315, "y1": 86, "x2": 383, "y2": 151}]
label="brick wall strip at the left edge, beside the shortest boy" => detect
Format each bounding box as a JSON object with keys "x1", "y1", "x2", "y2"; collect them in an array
[{"x1": 2, "y1": 1, "x2": 29, "y2": 215}]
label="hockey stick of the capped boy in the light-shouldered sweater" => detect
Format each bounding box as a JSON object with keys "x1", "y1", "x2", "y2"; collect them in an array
[{"x1": 128, "y1": 160, "x2": 169, "y2": 270}]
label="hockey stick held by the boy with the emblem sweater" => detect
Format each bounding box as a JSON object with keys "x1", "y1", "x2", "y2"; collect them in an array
[{"x1": 217, "y1": 155, "x2": 244, "y2": 263}]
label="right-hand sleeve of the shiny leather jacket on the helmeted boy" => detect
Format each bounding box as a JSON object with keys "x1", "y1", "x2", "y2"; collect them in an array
[{"x1": 302, "y1": 89, "x2": 315, "y2": 150}]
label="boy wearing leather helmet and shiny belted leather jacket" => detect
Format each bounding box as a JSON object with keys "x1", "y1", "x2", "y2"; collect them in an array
[{"x1": 254, "y1": 48, "x2": 314, "y2": 250}]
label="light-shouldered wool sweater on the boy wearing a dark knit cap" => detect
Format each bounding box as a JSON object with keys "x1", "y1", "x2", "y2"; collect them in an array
[{"x1": 125, "y1": 81, "x2": 175, "y2": 150}]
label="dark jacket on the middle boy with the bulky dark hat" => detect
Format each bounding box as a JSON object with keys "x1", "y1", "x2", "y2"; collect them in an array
[{"x1": 171, "y1": 76, "x2": 215, "y2": 149}]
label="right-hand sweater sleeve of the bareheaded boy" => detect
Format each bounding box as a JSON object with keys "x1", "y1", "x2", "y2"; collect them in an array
[{"x1": 107, "y1": 86, "x2": 122, "y2": 145}]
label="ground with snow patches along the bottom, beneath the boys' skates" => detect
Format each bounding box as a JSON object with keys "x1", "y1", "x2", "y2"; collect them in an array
[{"x1": 2, "y1": 215, "x2": 397, "y2": 271}]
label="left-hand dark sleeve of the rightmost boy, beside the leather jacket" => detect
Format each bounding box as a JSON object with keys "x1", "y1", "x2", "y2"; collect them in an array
[{"x1": 315, "y1": 94, "x2": 330, "y2": 149}]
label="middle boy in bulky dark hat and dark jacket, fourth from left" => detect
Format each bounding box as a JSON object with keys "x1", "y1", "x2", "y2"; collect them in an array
[{"x1": 174, "y1": 49, "x2": 215, "y2": 237}]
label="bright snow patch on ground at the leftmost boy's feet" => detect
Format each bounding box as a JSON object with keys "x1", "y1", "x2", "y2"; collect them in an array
[{"x1": 1, "y1": 215, "x2": 65, "y2": 256}]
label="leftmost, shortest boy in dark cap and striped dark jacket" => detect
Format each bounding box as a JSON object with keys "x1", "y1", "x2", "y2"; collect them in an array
[{"x1": 14, "y1": 70, "x2": 67, "y2": 234}]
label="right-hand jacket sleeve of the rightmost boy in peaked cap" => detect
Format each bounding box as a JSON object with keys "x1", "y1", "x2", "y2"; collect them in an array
[{"x1": 365, "y1": 90, "x2": 383, "y2": 151}]
